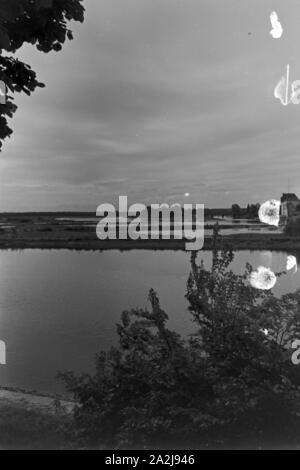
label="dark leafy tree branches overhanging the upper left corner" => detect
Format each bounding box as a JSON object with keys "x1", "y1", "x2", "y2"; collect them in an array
[{"x1": 0, "y1": 0, "x2": 84, "y2": 149}]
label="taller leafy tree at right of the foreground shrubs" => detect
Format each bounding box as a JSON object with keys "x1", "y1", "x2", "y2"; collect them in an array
[{"x1": 187, "y1": 235, "x2": 300, "y2": 445}]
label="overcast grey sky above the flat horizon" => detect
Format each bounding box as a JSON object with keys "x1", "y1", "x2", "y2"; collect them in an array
[{"x1": 0, "y1": 0, "x2": 300, "y2": 212}]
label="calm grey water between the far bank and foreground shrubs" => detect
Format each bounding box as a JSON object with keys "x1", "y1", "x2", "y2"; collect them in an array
[{"x1": 0, "y1": 250, "x2": 300, "y2": 392}]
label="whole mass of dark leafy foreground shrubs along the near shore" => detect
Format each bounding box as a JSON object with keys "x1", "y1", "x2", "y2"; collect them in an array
[{"x1": 63, "y1": 235, "x2": 300, "y2": 448}]
